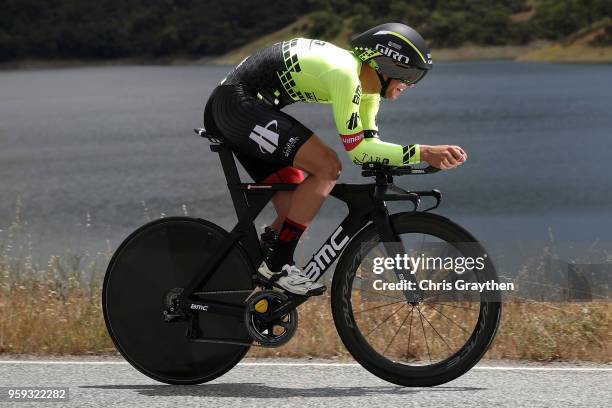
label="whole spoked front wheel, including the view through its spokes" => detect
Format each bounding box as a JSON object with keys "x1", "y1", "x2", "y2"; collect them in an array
[{"x1": 332, "y1": 213, "x2": 501, "y2": 387}]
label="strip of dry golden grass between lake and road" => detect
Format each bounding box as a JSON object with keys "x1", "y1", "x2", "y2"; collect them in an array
[{"x1": 0, "y1": 204, "x2": 612, "y2": 362}]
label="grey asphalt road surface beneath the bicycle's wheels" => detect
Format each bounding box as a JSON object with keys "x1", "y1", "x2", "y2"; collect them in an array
[{"x1": 0, "y1": 359, "x2": 612, "y2": 408}]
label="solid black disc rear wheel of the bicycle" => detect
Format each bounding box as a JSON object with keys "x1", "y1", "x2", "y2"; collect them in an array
[{"x1": 102, "y1": 217, "x2": 254, "y2": 384}]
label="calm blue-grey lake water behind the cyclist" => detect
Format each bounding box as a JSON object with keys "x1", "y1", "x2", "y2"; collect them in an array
[{"x1": 0, "y1": 61, "x2": 612, "y2": 270}]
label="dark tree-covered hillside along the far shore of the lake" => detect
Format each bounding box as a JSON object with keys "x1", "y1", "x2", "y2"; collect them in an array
[{"x1": 0, "y1": 0, "x2": 612, "y2": 63}]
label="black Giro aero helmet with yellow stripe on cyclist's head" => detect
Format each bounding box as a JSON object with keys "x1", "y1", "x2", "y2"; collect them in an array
[{"x1": 351, "y1": 23, "x2": 432, "y2": 88}]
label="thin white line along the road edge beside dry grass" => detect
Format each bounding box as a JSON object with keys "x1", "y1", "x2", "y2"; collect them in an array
[{"x1": 0, "y1": 360, "x2": 612, "y2": 372}]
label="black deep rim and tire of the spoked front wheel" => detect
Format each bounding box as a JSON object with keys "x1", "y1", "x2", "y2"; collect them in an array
[{"x1": 331, "y1": 213, "x2": 502, "y2": 387}]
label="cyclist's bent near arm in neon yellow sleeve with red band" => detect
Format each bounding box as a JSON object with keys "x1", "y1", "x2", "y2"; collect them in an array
[{"x1": 326, "y1": 70, "x2": 420, "y2": 166}]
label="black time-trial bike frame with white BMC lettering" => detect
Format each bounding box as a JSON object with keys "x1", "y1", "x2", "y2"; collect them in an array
[{"x1": 179, "y1": 129, "x2": 440, "y2": 316}]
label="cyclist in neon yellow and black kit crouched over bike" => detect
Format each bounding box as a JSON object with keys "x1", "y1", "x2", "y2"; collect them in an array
[{"x1": 204, "y1": 23, "x2": 467, "y2": 296}]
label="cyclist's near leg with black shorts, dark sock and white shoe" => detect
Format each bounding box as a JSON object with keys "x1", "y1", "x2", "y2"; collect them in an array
[{"x1": 205, "y1": 86, "x2": 328, "y2": 295}]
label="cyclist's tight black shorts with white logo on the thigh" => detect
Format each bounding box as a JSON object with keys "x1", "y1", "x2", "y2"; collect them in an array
[{"x1": 204, "y1": 85, "x2": 312, "y2": 182}]
